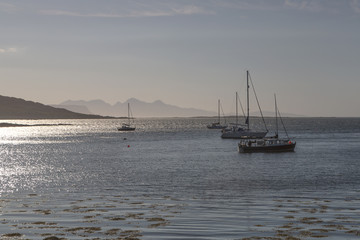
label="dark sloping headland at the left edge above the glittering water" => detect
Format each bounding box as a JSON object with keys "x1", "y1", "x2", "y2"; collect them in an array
[{"x1": 0, "y1": 96, "x2": 110, "y2": 119}]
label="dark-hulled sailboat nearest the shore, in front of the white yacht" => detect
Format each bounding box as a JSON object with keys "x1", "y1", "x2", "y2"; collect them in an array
[{"x1": 238, "y1": 95, "x2": 296, "y2": 153}]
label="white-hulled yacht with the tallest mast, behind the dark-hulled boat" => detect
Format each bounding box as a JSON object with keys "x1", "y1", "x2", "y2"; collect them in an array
[{"x1": 221, "y1": 71, "x2": 268, "y2": 139}]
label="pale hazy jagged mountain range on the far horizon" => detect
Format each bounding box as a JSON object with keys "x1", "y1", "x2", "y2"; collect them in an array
[{"x1": 56, "y1": 98, "x2": 217, "y2": 118}]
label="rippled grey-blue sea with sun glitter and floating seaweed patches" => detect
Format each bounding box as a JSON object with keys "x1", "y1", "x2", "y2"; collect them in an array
[{"x1": 0, "y1": 118, "x2": 360, "y2": 239}]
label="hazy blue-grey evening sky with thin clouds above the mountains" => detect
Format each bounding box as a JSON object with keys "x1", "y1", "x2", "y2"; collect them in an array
[{"x1": 0, "y1": 0, "x2": 360, "y2": 117}]
